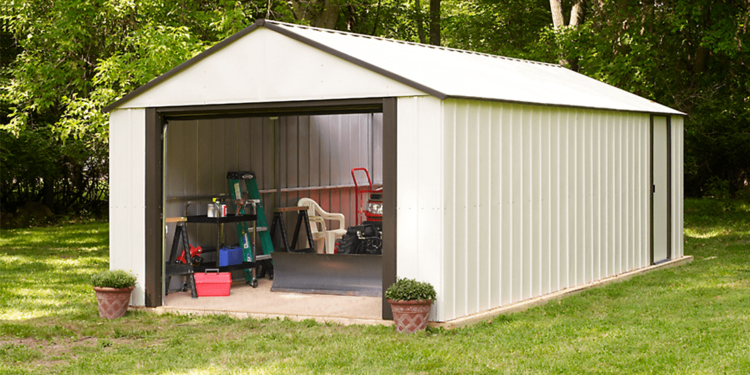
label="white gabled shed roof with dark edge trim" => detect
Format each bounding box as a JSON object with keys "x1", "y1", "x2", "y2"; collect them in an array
[{"x1": 105, "y1": 20, "x2": 683, "y2": 115}]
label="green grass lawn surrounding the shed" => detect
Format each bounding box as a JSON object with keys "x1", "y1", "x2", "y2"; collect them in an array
[{"x1": 0, "y1": 200, "x2": 750, "y2": 374}]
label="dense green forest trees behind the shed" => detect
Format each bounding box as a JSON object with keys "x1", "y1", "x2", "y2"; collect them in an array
[{"x1": 0, "y1": 0, "x2": 750, "y2": 225}]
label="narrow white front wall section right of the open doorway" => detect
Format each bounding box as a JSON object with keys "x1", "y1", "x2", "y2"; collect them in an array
[{"x1": 396, "y1": 97, "x2": 444, "y2": 320}]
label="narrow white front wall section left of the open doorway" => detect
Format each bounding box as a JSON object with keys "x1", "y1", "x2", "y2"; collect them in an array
[{"x1": 109, "y1": 109, "x2": 146, "y2": 306}]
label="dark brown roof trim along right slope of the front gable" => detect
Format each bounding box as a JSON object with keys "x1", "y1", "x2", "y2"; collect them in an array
[{"x1": 258, "y1": 20, "x2": 448, "y2": 100}]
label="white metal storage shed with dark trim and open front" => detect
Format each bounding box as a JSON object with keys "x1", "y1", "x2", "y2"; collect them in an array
[{"x1": 105, "y1": 20, "x2": 684, "y2": 321}]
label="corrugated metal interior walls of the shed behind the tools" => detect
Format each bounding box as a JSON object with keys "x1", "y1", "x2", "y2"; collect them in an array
[{"x1": 165, "y1": 114, "x2": 382, "y2": 262}]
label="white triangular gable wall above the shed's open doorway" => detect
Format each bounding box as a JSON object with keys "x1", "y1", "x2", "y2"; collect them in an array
[{"x1": 118, "y1": 27, "x2": 426, "y2": 109}]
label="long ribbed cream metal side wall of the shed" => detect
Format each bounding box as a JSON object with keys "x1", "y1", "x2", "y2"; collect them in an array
[{"x1": 444, "y1": 100, "x2": 650, "y2": 320}]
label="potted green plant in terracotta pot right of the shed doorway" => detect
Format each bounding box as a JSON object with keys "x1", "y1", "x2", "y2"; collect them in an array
[{"x1": 385, "y1": 278, "x2": 437, "y2": 333}]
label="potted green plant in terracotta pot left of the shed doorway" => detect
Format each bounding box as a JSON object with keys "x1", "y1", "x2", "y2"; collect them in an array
[{"x1": 91, "y1": 270, "x2": 136, "y2": 319}]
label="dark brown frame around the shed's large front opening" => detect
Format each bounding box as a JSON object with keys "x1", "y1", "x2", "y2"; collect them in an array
[{"x1": 144, "y1": 97, "x2": 398, "y2": 319}]
